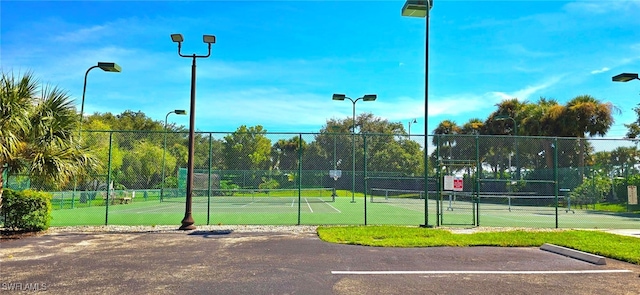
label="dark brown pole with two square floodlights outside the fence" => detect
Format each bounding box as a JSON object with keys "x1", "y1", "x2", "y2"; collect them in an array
[{"x1": 171, "y1": 34, "x2": 216, "y2": 230}]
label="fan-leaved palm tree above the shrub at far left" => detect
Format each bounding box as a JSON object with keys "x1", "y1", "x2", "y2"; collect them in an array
[{"x1": 0, "y1": 72, "x2": 98, "y2": 206}]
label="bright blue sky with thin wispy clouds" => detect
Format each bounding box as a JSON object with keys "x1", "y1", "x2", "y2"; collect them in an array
[{"x1": 0, "y1": 0, "x2": 640, "y2": 138}]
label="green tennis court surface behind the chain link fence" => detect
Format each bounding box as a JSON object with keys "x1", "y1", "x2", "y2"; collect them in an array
[{"x1": 51, "y1": 189, "x2": 640, "y2": 228}]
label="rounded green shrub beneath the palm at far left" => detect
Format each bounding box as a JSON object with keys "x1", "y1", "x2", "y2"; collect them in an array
[{"x1": 0, "y1": 189, "x2": 51, "y2": 231}]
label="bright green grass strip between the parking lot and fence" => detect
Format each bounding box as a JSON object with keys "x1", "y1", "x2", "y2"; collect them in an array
[{"x1": 318, "y1": 226, "x2": 640, "y2": 265}]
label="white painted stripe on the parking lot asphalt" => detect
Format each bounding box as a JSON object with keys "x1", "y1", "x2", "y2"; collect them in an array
[{"x1": 331, "y1": 269, "x2": 632, "y2": 275}]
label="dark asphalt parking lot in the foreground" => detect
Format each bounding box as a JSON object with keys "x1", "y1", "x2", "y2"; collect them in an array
[{"x1": 0, "y1": 230, "x2": 640, "y2": 295}]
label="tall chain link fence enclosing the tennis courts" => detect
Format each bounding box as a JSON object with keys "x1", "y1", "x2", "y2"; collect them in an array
[{"x1": 4, "y1": 131, "x2": 640, "y2": 228}]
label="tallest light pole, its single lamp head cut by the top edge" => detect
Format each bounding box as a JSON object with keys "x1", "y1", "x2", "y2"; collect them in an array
[{"x1": 402, "y1": 0, "x2": 432, "y2": 227}]
